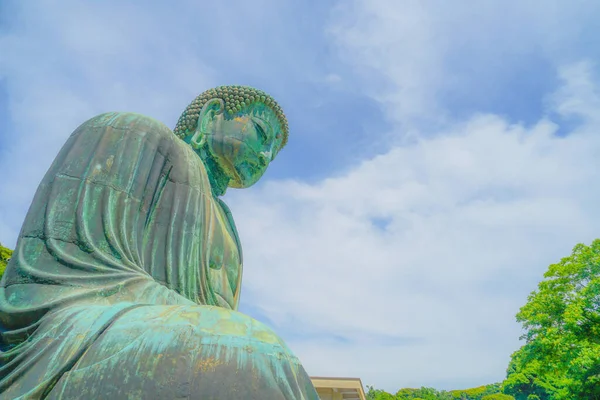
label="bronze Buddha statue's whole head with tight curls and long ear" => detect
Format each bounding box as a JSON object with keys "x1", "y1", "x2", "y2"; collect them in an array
[{"x1": 174, "y1": 86, "x2": 288, "y2": 189}]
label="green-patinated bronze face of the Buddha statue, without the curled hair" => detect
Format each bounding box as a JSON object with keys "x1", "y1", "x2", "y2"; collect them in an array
[{"x1": 204, "y1": 104, "x2": 283, "y2": 188}]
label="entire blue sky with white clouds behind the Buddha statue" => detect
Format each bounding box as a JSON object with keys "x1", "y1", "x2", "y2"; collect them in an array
[{"x1": 0, "y1": 0, "x2": 600, "y2": 392}]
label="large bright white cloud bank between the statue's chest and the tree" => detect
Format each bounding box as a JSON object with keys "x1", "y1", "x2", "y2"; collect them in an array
[{"x1": 230, "y1": 63, "x2": 600, "y2": 391}]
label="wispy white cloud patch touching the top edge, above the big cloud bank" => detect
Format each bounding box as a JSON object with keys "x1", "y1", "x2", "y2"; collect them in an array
[{"x1": 329, "y1": 0, "x2": 443, "y2": 126}]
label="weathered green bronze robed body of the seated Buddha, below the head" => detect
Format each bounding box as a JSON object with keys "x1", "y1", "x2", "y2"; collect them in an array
[{"x1": 0, "y1": 113, "x2": 318, "y2": 400}]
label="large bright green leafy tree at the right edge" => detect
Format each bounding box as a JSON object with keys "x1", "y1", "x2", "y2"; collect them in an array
[{"x1": 503, "y1": 240, "x2": 600, "y2": 400}]
